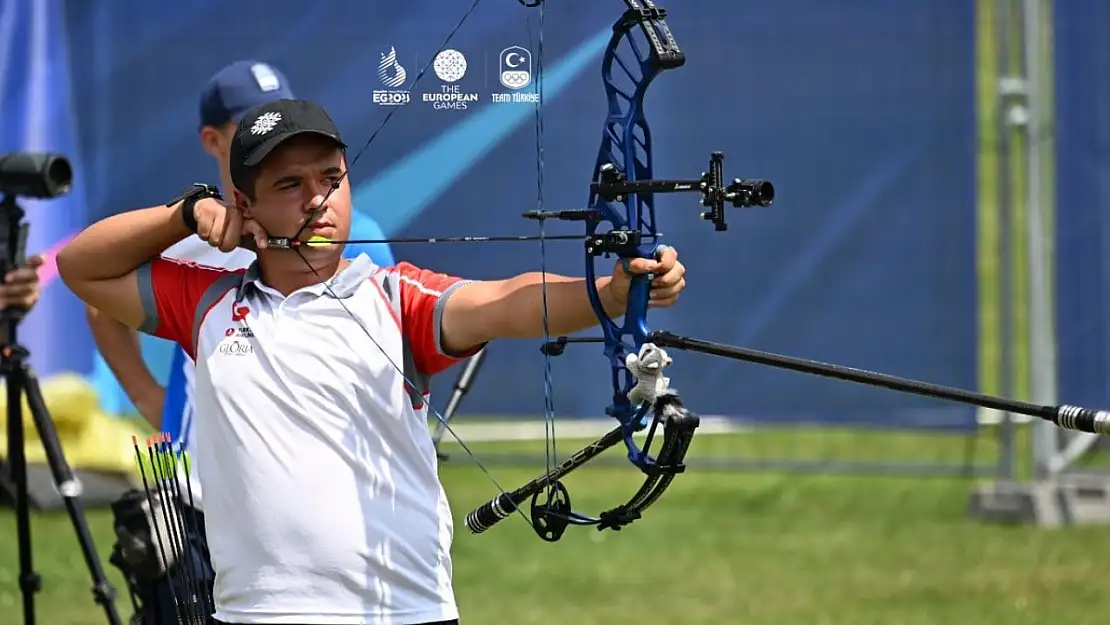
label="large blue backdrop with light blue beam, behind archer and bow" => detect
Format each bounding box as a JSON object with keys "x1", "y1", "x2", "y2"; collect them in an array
[{"x1": 60, "y1": 0, "x2": 976, "y2": 427}]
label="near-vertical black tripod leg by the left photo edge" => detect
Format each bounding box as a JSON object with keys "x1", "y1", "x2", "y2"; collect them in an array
[{"x1": 4, "y1": 353, "x2": 42, "y2": 625}]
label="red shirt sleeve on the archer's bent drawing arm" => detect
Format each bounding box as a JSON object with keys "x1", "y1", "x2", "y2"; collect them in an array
[{"x1": 139, "y1": 258, "x2": 235, "y2": 360}]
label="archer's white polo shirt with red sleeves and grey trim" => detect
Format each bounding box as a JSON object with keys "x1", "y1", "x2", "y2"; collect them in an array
[{"x1": 139, "y1": 255, "x2": 470, "y2": 625}]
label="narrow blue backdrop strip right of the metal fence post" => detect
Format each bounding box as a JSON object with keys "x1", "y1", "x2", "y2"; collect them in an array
[{"x1": 1053, "y1": 0, "x2": 1110, "y2": 405}]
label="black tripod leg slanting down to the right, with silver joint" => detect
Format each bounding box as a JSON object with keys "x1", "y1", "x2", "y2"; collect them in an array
[{"x1": 20, "y1": 364, "x2": 120, "y2": 625}]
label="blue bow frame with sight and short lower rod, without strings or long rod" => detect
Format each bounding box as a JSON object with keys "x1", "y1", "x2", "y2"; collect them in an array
[{"x1": 466, "y1": 0, "x2": 774, "y2": 541}]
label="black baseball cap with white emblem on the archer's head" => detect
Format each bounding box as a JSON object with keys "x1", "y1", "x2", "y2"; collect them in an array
[{"x1": 229, "y1": 99, "x2": 346, "y2": 189}]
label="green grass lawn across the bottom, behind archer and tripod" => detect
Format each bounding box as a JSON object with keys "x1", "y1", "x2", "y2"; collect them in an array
[{"x1": 0, "y1": 431, "x2": 1110, "y2": 625}]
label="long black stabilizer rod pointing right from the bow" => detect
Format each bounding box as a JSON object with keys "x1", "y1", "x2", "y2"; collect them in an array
[{"x1": 647, "y1": 332, "x2": 1110, "y2": 434}]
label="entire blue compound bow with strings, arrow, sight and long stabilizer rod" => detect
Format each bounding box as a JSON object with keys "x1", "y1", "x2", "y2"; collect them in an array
[{"x1": 270, "y1": 0, "x2": 1110, "y2": 542}]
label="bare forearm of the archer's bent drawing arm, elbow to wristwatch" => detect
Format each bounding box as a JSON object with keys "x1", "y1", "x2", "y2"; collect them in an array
[{"x1": 58, "y1": 202, "x2": 192, "y2": 281}]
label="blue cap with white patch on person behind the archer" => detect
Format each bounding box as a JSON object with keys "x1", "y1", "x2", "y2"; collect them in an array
[{"x1": 200, "y1": 61, "x2": 294, "y2": 128}]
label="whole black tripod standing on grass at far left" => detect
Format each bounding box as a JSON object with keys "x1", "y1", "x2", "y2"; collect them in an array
[{"x1": 0, "y1": 195, "x2": 120, "y2": 625}]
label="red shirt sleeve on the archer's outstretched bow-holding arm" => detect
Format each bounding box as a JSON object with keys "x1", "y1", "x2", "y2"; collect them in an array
[{"x1": 395, "y1": 262, "x2": 481, "y2": 375}]
